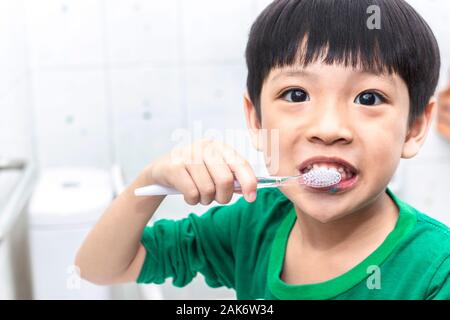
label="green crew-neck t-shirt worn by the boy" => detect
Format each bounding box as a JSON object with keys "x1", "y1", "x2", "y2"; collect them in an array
[{"x1": 137, "y1": 188, "x2": 450, "y2": 299}]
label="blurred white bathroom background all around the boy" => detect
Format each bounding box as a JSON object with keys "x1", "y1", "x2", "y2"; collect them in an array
[{"x1": 0, "y1": 0, "x2": 450, "y2": 299}]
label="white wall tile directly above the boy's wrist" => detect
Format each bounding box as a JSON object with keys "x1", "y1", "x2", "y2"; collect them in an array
[{"x1": 110, "y1": 66, "x2": 183, "y2": 181}]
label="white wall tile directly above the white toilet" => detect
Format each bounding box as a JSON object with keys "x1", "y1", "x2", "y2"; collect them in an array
[{"x1": 33, "y1": 68, "x2": 110, "y2": 168}]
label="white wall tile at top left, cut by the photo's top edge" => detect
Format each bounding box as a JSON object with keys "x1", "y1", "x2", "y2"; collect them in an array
[{"x1": 25, "y1": 0, "x2": 104, "y2": 67}]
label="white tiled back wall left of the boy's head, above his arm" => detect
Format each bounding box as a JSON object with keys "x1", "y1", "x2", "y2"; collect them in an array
[{"x1": 20, "y1": 0, "x2": 267, "y2": 298}]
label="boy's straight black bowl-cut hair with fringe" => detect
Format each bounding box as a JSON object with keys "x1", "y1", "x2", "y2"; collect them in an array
[{"x1": 245, "y1": 0, "x2": 441, "y2": 125}]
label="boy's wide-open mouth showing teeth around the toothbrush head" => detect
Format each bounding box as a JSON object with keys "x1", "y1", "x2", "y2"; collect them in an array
[{"x1": 298, "y1": 157, "x2": 359, "y2": 193}]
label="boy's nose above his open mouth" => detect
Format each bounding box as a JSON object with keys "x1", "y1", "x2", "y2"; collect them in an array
[{"x1": 306, "y1": 105, "x2": 353, "y2": 145}]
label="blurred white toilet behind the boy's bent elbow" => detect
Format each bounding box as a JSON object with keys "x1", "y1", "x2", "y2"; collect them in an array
[{"x1": 28, "y1": 167, "x2": 113, "y2": 300}]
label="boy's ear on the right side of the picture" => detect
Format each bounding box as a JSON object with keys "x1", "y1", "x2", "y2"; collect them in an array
[{"x1": 402, "y1": 97, "x2": 436, "y2": 159}]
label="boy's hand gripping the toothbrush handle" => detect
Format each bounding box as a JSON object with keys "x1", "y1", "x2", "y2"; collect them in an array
[{"x1": 145, "y1": 140, "x2": 257, "y2": 205}]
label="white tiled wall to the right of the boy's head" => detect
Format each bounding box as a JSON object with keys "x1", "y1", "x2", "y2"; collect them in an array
[{"x1": 401, "y1": 0, "x2": 450, "y2": 225}]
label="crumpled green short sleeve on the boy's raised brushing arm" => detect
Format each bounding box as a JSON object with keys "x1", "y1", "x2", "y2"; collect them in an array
[{"x1": 136, "y1": 197, "x2": 245, "y2": 288}]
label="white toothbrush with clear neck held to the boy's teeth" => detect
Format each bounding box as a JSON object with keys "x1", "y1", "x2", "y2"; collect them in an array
[{"x1": 134, "y1": 168, "x2": 342, "y2": 196}]
